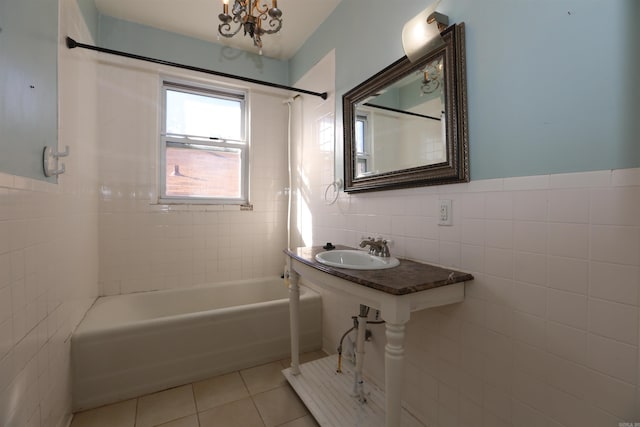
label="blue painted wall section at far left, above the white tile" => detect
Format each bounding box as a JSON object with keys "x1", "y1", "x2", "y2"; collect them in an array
[{"x1": 0, "y1": 0, "x2": 58, "y2": 182}]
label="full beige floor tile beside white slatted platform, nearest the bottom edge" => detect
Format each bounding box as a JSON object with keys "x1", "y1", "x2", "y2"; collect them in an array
[{"x1": 253, "y1": 384, "x2": 309, "y2": 427}]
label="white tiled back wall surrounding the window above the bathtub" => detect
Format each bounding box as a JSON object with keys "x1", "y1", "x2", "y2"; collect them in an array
[{"x1": 98, "y1": 57, "x2": 288, "y2": 295}]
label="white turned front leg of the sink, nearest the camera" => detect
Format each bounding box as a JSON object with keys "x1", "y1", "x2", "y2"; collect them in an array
[{"x1": 384, "y1": 322, "x2": 404, "y2": 427}]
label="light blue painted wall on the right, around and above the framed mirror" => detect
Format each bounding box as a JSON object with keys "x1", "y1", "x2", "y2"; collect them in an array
[{"x1": 289, "y1": 0, "x2": 640, "y2": 179}]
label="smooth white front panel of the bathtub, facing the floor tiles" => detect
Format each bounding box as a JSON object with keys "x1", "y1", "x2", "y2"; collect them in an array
[{"x1": 71, "y1": 282, "x2": 322, "y2": 411}]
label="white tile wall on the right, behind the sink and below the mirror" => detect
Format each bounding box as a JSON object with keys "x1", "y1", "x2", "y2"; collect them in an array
[{"x1": 296, "y1": 51, "x2": 640, "y2": 427}]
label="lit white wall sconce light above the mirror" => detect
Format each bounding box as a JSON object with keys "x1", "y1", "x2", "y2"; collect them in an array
[{"x1": 402, "y1": 0, "x2": 449, "y2": 62}]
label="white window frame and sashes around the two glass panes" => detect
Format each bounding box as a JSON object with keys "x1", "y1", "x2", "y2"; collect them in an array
[{"x1": 158, "y1": 77, "x2": 250, "y2": 205}]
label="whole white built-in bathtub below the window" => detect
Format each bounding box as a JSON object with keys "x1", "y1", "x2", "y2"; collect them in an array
[{"x1": 71, "y1": 278, "x2": 322, "y2": 411}]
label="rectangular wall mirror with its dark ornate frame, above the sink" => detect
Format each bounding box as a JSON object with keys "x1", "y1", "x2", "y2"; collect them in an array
[{"x1": 342, "y1": 23, "x2": 469, "y2": 192}]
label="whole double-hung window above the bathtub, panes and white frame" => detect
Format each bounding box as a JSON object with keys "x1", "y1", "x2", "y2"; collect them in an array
[{"x1": 159, "y1": 81, "x2": 249, "y2": 204}]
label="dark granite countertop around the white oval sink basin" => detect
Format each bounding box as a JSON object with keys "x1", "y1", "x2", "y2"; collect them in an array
[{"x1": 284, "y1": 245, "x2": 473, "y2": 295}]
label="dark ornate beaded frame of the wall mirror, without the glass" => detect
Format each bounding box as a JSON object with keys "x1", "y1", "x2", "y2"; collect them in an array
[{"x1": 342, "y1": 23, "x2": 469, "y2": 192}]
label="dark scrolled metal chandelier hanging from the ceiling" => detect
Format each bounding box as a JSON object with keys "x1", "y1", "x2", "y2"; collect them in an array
[{"x1": 218, "y1": 0, "x2": 282, "y2": 55}]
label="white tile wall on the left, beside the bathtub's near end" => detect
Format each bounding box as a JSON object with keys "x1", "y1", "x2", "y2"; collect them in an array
[{"x1": 0, "y1": 0, "x2": 98, "y2": 427}]
